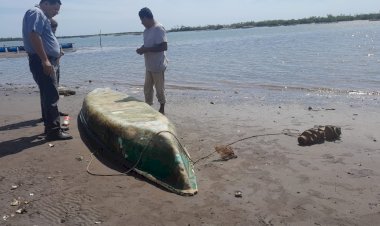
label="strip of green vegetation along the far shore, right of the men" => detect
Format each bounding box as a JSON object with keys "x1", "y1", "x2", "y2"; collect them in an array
[{"x1": 169, "y1": 13, "x2": 380, "y2": 32}]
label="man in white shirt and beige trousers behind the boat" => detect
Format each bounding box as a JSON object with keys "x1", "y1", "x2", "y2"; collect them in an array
[{"x1": 136, "y1": 8, "x2": 168, "y2": 114}]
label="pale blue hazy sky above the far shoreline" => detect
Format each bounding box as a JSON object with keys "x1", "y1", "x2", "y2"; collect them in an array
[{"x1": 0, "y1": 0, "x2": 380, "y2": 37}]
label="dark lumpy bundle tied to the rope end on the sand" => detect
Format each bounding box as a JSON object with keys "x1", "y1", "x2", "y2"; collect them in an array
[{"x1": 298, "y1": 125, "x2": 342, "y2": 146}]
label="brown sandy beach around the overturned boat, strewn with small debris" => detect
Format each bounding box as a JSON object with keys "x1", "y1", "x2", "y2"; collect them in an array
[{"x1": 0, "y1": 85, "x2": 380, "y2": 226}]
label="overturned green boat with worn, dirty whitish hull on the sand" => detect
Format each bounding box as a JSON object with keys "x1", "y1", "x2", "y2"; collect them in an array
[{"x1": 79, "y1": 88, "x2": 198, "y2": 195}]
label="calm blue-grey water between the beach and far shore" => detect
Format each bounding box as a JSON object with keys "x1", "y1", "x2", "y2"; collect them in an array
[{"x1": 0, "y1": 21, "x2": 380, "y2": 106}]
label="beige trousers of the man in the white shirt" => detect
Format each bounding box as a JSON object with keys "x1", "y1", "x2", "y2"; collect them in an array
[{"x1": 144, "y1": 71, "x2": 166, "y2": 105}]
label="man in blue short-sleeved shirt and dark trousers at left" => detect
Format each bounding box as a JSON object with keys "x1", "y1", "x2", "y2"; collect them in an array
[{"x1": 22, "y1": 0, "x2": 72, "y2": 140}]
